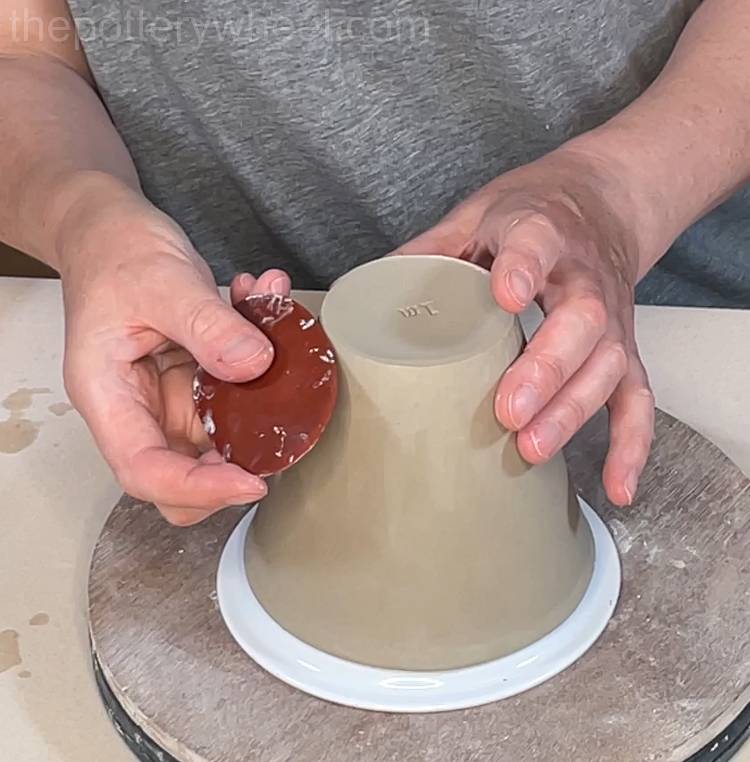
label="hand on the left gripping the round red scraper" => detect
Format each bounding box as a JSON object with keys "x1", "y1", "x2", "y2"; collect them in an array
[{"x1": 59, "y1": 177, "x2": 290, "y2": 525}]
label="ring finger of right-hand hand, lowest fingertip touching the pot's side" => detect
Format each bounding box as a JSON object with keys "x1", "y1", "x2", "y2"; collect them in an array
[{"x1": 517, "y1": 338, "x2": 628, "y2": 463}]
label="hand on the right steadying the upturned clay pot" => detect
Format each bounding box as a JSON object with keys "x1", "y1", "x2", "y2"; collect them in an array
[{"x1": 394, "y1": 147, "x2": 654, "y2": 505}]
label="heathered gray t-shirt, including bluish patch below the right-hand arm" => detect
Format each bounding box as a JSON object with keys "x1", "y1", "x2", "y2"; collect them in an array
[{"x1": 70, "y1": 0, "x2": 750, "y2": 307}]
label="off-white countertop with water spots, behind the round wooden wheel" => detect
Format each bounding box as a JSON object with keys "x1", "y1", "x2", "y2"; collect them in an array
[{"x1": 0, "y1": 278, "x2": 750, "y2": 762}]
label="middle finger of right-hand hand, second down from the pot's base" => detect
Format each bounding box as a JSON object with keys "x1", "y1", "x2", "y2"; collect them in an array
[{"x1": 495, "y1": 282, "x2": 608, "y2": 431}]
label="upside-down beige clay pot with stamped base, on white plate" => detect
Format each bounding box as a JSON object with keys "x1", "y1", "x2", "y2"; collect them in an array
[{"x1": 247, "y1": 256, "x2": 593, "y2": 670}]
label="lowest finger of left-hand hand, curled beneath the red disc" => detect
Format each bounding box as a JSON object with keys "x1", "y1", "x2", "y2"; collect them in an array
[{"x1": 69, "y1": 358, "x2": 266, "y2": 511}]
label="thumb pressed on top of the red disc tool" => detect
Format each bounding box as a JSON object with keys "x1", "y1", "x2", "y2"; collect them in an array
[{"x1": 159, "y1": 281, "x2": 273, "y2": 382}]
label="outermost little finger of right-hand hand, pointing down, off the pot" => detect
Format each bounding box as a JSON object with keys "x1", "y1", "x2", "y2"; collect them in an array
[{"x1": 603, "y1": 357, "x2": 654, "y2": 505}]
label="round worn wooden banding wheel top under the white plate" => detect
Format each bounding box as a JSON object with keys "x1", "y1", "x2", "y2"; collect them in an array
[{"x1": 89, "y1": 412, "x2": 750, "y2": 762}]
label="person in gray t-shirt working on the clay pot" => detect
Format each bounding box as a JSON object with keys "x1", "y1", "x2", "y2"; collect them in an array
[{"x1": 0, "y1": 0, "x2": 750, "y2": 525}]
